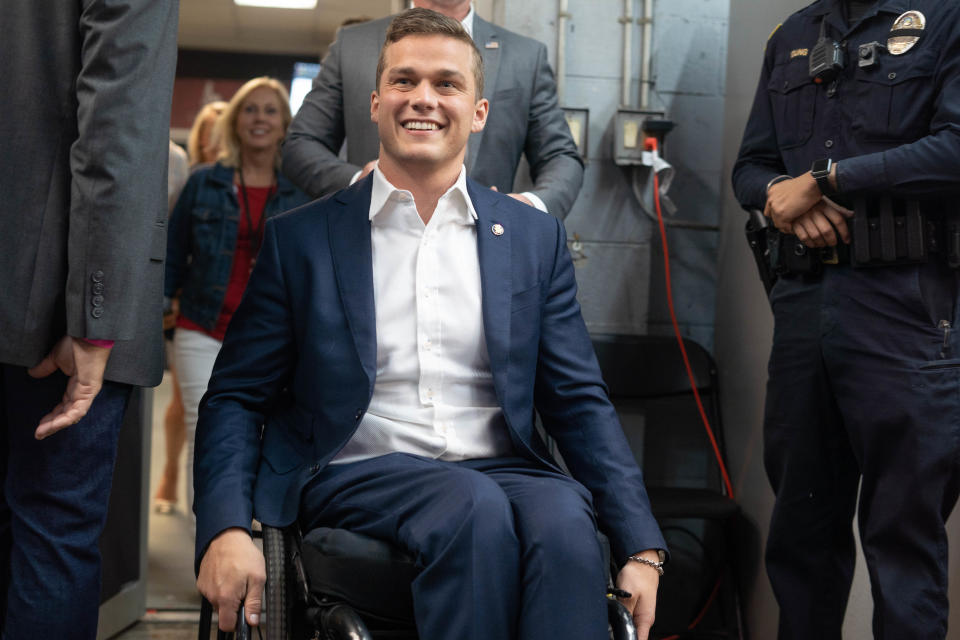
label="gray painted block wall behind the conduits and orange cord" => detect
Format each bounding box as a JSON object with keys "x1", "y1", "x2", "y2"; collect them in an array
[{"x1": 488, "y1": 0, "x2": 728, "y2": 349}]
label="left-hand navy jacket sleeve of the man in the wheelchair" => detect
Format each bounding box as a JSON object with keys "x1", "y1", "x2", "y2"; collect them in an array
[{"x1": 193, "y1": 220, "x2": 296, "y2": 568}]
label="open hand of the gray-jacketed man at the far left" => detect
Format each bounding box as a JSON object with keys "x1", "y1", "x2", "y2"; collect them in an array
[{"x1": 27, "y1": 336, "x2": 110, "y2": 440}]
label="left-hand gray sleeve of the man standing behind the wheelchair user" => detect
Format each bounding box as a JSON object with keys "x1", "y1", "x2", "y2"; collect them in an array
[{"x1": 283, "y1": 40, "x2": 361, "y2": 198}]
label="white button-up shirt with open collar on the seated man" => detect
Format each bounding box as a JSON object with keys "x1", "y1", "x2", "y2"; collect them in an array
[{"x1": 333, "y1": 168, "x2": 513, "y2": 463}]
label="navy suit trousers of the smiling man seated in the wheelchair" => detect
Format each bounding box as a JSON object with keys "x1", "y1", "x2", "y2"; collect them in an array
[{"x1": 301, "y1": 453, "x2": 607, "y2": 640}]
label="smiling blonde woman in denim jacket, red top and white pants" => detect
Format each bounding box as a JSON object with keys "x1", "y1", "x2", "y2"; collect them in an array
[{"x1": 164, "y1": 77, "x2": 309, "y2": 503}]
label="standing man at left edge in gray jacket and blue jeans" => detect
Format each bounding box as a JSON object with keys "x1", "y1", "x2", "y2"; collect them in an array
[{"x1": 0, "y1": 0, "x2": 177, "y2": 639}]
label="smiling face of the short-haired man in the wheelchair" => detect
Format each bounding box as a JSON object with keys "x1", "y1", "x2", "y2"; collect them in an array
[{"x1": 370, "y1": 35, "x2": 489, "y2": 180}]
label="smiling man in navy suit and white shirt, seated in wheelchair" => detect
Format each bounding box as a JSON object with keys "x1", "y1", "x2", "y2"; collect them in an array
[{"x1": 194, "y1": 9, "x2": 666, "y2": 640}]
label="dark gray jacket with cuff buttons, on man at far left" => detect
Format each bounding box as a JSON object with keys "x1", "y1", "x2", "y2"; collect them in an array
[{"x1": 0, "y1": 0, "x2": 178, "y2": 385}]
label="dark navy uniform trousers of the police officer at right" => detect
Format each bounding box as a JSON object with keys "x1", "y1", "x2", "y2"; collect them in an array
[{"x1": 764, "y1": 264, "x2": 960, "y2": 640}]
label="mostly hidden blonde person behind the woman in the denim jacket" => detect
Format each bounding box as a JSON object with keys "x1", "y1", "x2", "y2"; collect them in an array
[{"x1": 153, "y1": 100, "x2": 227, "y2": 515}]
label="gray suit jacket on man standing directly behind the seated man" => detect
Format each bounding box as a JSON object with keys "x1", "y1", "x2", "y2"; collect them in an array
[{"x1": 283, "y1": 16, "x2": 583, "y2": 218}]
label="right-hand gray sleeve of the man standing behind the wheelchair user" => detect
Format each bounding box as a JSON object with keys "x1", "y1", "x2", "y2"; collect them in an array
[{"x1": 524, "y1": 43, "x2": 583, "y2": 220}]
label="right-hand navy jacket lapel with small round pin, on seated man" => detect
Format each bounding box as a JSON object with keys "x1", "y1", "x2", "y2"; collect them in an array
[{"x1": 467, "y1": 179, "x2": 512, "y2": 402}]
